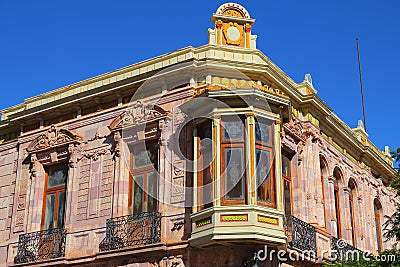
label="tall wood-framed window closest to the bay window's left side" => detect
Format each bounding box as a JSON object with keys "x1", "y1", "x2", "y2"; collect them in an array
[{"x1": 128, "y1": 142, "x2": 158, "y2": 214}]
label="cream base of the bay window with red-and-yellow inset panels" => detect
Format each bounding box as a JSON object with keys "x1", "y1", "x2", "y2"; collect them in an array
[{"x1": 190, "y1": 205, "x2": 286, "y2": 247}]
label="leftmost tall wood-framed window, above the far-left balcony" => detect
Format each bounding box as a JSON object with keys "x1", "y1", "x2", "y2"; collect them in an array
[{"x1": 42, "y1": 165, "x2": 68, "y2": 230}]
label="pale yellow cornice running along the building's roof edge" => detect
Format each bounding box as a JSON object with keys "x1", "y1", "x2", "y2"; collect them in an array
[{"x1": 0, "y1": 44, "x2": 395, "y2": 178}]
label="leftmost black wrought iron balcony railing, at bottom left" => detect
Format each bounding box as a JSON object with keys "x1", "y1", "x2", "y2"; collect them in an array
[{"x1": 14, "y1": 228, "x2": 67, "y2": 263}]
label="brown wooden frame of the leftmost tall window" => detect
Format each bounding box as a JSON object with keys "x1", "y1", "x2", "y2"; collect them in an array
[{"x1": 40, "y1": 162, "x2": 69, "y2": 231}]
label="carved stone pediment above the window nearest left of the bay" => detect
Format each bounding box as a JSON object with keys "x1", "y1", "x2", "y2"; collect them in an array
[{"x1": 109, "y1": 101, "x2": 168, "y2": 131}]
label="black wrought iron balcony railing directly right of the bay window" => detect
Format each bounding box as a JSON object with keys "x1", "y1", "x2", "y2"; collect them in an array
[{"x1": 285, "y1": 215, "x2": 317, "y2": 257}]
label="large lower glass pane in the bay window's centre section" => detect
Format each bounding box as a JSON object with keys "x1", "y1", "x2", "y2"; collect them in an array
[{"x1": 225, "y1": 147, "x2": 245, "y2": 199}]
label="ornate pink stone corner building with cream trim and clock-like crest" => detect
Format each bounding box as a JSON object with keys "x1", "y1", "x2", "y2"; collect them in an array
[{"x1": 0, "y1": 3, "x2": 399, "y2": 267}]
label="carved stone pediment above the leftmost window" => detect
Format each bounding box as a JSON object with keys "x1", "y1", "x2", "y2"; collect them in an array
[{"x1": 27, "y1": 125, "x2": 82, "y2": 153}]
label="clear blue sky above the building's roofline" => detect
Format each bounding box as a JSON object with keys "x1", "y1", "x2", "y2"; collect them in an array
[{"x1": 0, "y1": 0, "x2": 400, "y2": 159}]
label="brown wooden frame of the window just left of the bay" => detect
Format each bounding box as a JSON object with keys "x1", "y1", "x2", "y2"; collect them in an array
[{"x1": 128, "y1": 140, "x2": 159, "y2": 214}]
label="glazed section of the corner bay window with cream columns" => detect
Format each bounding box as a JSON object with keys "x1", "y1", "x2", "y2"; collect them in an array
[{"x1": 196, "y1": 115, "x2": 275, "y2": 210}]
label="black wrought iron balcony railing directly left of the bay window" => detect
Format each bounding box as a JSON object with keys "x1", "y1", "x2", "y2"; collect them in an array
[{"x1": 99, "y1": 212, "x2": 161, "y2": 251}]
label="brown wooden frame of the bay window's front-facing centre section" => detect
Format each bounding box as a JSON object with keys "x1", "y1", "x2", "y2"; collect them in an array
[{"x1": 219, "y1": 115, "x2": 249, "y2": 206}]
